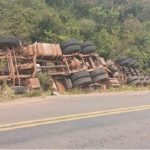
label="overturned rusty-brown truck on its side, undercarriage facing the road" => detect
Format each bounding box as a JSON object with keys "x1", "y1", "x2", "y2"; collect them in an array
[{"x1": 0, "y1": 37, "x2": 150, "y2": 92}]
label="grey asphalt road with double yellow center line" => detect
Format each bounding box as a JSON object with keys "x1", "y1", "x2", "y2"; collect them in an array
[{"x1": 0, "y1": 91, "x2": 150, "y2": 149}]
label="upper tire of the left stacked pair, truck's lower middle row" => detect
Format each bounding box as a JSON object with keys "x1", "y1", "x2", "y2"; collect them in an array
[{"x1": 71, "y1": 71, "x2": 90, "y2": 82}]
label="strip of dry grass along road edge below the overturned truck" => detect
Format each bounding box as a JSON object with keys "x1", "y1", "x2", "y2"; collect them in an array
[{"x1": 0, "y1": 85, "x2": 150, "y2": 102}]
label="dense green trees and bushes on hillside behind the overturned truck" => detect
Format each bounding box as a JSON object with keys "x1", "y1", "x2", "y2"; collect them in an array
[{"x1": 0, "y1": 0, "x2": 150, "y2": 69}]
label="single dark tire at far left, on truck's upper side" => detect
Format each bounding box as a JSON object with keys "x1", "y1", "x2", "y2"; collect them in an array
[{"x1": 0, "y1": 36, "x2": 21, "y2": 49}]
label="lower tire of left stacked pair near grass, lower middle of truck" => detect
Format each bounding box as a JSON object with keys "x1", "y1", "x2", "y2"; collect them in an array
[{"x1": 73, "y1": 77, "x2": 92, "y2": 87}]
